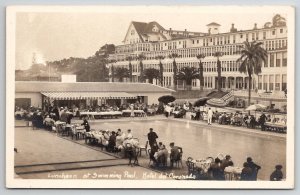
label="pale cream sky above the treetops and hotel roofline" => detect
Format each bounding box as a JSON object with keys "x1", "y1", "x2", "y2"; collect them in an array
[{"x1": 15, "y1": 7, "x2": 284, "y2": 69}]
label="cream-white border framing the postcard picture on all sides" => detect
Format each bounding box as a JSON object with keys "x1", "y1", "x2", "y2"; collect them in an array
[{"x1": 6, "y1": 6, "x2": 295, "y2": 189}]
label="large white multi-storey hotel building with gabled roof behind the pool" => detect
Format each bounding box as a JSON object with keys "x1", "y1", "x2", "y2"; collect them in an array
[{"x1": 109, "y1": 17, "x2": 287, "y2": 93}]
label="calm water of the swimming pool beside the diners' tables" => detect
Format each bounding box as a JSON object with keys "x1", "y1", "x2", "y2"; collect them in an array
[{"x1": 91, "y1": 119, "x2": 286, "y2": 180}]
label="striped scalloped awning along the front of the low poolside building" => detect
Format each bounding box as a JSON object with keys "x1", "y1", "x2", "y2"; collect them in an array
[{"x1": 41, "y1": 92, "x2": 136, "y2": 100}]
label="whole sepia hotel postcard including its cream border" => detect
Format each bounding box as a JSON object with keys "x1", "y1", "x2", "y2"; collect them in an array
[{"x1": 6, "y1": 6, "x2": 295, "y2": 189}]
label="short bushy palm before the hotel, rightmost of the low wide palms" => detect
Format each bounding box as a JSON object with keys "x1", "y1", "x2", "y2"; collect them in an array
[{"x1": 176, "y1": 67, "x2": 199, "y2": 90}]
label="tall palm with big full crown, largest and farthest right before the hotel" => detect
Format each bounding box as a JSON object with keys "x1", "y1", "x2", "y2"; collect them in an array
[{"x1": 237, "y1": 41, "x2": 267, "y2": 106}]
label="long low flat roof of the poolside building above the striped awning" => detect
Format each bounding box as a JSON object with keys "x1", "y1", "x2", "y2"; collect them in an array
[{"x1": 15, "y1": 81, "x2": 173, "y2": 93}]
